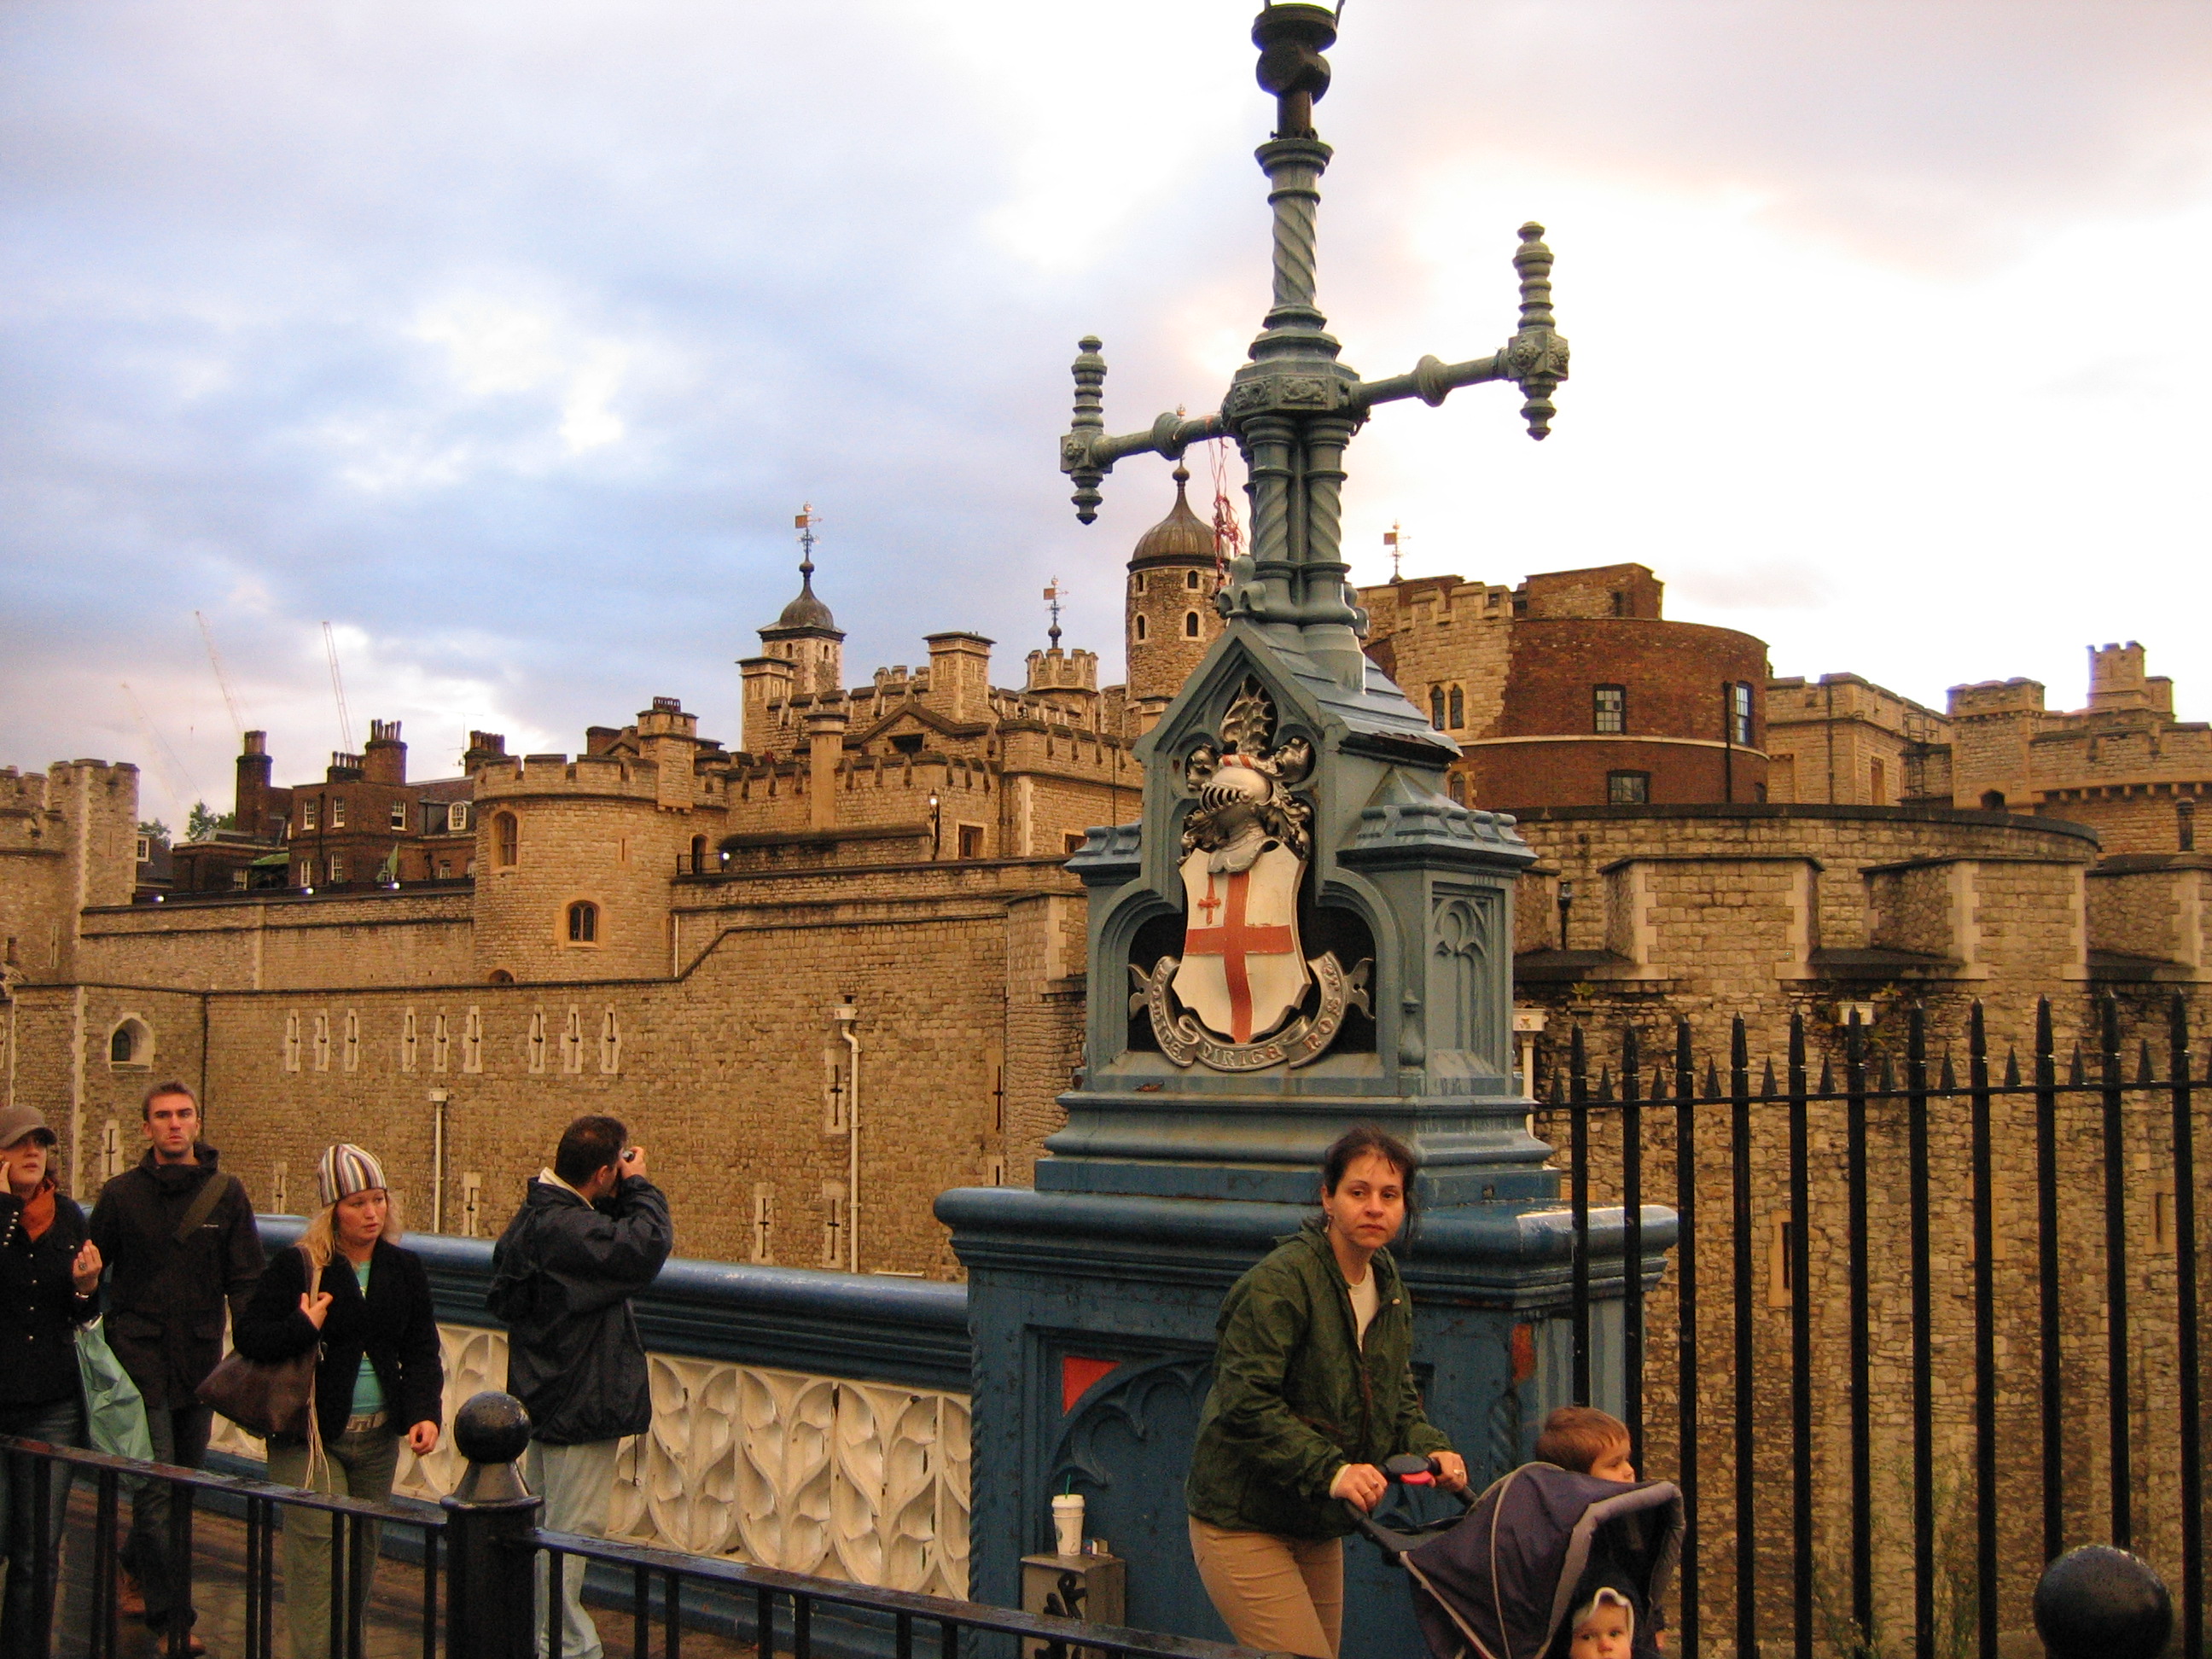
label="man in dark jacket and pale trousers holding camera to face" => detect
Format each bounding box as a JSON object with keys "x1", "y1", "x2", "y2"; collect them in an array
[{"x1": 485, "y1": 1117, "x2": 675, "y2": 1659}]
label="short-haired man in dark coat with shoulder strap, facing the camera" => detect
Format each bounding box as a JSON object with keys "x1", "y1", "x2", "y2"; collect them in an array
[{"x1": 93, "y1": 1084, "x2": 261, "y2": 1652}]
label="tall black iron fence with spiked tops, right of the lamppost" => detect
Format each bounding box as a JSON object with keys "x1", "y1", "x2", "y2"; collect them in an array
[{"x1": 1546, "y1": 995, "x2": 2212, "y2": 1659}]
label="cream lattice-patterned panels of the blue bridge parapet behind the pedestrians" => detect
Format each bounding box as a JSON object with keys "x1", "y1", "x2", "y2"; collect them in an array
[{"x1": 214, "y1": 1325, "x2": 969, "y2": 1599}]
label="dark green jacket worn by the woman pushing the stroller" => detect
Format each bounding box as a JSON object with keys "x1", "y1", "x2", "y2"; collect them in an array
[{"x1": 1184, "y1": 1223, "x2": 1451, "y2": 1537}]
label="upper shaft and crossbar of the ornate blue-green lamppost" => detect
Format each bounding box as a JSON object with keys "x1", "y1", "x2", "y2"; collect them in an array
[{"x1": 1060, "y1": 4, "x2": 1566, "y2": 686}]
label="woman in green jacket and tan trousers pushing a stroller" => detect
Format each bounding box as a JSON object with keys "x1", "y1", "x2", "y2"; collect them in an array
[{"x1": 1184, "y1": 1126, "x2": 1466, "y2": 1659}]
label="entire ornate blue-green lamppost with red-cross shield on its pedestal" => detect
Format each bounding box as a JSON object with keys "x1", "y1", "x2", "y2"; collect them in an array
[{"x1": 938, "y1": 4, "x2": 1674, "y2": 1659}]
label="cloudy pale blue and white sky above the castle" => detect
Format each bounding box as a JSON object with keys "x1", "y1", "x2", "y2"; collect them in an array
[{"x1": 0, "y1": 0, "x2": 2212, "y2": 823}]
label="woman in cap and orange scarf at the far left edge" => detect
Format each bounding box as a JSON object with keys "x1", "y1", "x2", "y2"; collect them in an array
[{"x1": 0, "y1": 1106, "x2": 100, "y2": 1659}]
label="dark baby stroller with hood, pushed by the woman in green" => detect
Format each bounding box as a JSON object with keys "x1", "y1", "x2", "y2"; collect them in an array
[{"x1": 1348, "y1": 1456, "x2": 1684, "y2": 1659}]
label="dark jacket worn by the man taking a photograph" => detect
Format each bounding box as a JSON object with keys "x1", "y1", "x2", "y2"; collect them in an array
[{"x1": 485, "y1": 1174, "x2": 675, "y2": 1447}]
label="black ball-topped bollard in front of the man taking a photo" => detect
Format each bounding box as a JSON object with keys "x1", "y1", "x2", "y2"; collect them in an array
[{"x1": 442, "y1": 1391, "x2": 542, "y2": 1659}]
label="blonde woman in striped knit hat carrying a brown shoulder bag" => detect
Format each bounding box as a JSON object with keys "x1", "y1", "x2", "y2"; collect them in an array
[{"x1": 232, "y1": 1146, "x2": 445, "y2": 1659}]
